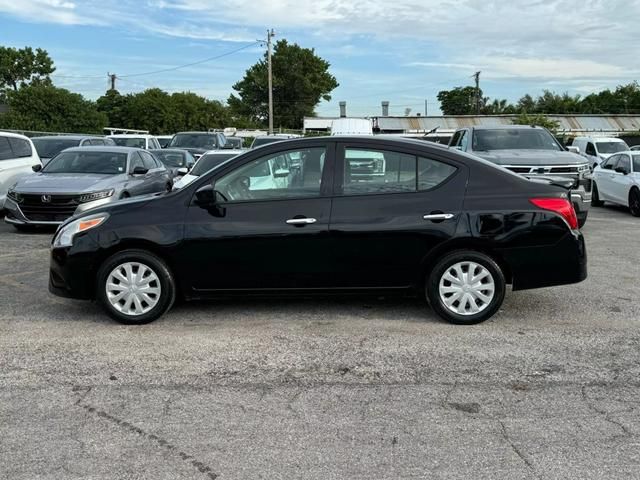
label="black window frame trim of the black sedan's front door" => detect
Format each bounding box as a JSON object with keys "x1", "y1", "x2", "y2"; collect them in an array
[{"x1": 191, "y1": 142, "x2": 336, "y2": 206}]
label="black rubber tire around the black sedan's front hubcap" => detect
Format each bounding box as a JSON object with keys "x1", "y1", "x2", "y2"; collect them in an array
[{"x1": 96, "y1": 250, "x2": 176, "y2": 325}]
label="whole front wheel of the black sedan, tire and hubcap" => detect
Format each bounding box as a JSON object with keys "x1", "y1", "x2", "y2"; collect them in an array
[{"x1": 96, "y1": 250, "x2": 176, "y2": 325}]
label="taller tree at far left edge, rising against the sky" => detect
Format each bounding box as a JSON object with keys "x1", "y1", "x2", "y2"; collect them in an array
[{"x1": 0, "y1": 46, "x2": 55, "y2": 93}]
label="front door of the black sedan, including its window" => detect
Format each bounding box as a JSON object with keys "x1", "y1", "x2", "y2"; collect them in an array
[{"x1": 180, "y1": 142, "x2": 333, "y2": 293}]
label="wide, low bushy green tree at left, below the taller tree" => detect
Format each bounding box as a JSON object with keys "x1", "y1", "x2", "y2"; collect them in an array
[{"x1": 0, "y1": 84, "x2": 107, "y2": 133}]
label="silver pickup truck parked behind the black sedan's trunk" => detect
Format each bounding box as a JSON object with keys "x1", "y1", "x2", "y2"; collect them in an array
[{"x1": 449, "y1": 125, "x2": 591, "y2": 227}]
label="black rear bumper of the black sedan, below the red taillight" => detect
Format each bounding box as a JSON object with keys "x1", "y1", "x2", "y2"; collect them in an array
[{"x1": 501, "y1": 232, "x2": 587, "y2": 290}]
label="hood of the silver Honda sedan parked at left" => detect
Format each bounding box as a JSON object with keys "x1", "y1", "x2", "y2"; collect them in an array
[{"x1": 14, "y1": 173, "x2": 126, "y2": 193}]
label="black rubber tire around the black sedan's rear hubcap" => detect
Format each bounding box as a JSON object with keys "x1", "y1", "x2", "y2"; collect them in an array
[{"x1": 425, "y1": 250, "x2": 506, "y2": 325}]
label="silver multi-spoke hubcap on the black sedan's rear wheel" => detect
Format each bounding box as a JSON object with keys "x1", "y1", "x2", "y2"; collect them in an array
[{"x1": 440, "y1": 262, "x2": 495, "y2": 315}]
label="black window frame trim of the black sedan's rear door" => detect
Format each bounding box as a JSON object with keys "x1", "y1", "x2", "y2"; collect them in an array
[{"x1": 332, "y1": 142, "x2": 464, "y2": 198}]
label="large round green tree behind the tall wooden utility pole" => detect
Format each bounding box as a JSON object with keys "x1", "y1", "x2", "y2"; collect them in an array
[{"x1": 227, "y1": 40, "x2": 338, "y2": 128}]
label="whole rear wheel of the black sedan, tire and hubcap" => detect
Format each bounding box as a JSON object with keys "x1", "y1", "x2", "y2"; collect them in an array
[{"x1": 426, "y1": 250, "x2": 505, "y2": 325}]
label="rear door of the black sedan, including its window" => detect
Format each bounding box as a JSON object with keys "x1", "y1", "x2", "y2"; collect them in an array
[{"x1": 329, "y1": 142, "x2": 467, "y2": 288}]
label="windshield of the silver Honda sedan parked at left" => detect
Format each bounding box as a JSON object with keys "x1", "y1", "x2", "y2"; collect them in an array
[{"x1": 42, "y1": 151, "x2": 127, "y2": 175}]
